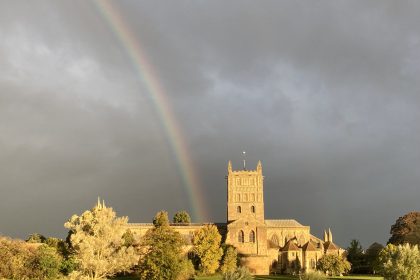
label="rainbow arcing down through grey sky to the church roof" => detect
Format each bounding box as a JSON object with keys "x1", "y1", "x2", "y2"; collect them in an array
[{"x1": 94, "y1": 0, "x2": 208, "y2": 221}]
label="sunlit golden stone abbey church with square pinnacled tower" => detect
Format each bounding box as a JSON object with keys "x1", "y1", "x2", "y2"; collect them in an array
[{"x1": 129, "y1": 161, "x2": 344, "y2": 275}]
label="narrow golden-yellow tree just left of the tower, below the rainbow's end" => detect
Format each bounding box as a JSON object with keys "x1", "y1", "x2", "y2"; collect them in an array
[{"x1": 193, "y1": 225, "x2": 223, "y2": 274}]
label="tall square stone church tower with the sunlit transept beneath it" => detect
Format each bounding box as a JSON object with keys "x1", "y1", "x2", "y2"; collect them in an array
[{"x1": 226, "y1": 161, "x2": 268, "y2": 274}]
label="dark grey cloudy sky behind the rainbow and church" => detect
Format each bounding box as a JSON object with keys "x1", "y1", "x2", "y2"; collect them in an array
[{"x1": 0, "y1": 1, "x2": 420, "y2": 247}]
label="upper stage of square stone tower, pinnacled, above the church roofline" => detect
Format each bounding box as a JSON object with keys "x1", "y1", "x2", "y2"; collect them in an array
[{"x1": 227, "y1": 159, "x2": 264, "y2": 223}]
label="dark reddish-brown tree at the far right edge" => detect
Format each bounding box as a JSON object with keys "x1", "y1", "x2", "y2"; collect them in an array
[{"x1": 388, "y1": 212, "x2": 420, "y2": 245}]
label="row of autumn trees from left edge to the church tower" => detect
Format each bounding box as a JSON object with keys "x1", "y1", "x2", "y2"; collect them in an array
[{"x1": 0, "y1": 203, "x2": 251, "y2": 280}]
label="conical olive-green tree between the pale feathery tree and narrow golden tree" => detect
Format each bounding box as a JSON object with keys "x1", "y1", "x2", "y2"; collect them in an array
[{"x1": 139, "y1": 211, "x2": 194, "y2": 280}]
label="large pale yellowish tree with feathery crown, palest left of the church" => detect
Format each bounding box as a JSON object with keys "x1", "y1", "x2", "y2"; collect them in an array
[{"x1": 64, "y1": 201, "x2": 138, "y2": 279}]
